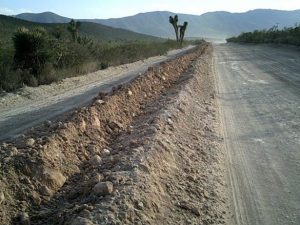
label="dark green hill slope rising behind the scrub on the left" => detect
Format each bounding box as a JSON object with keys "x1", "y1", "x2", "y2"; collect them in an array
[{"x1": 0, "y1": 15, "x2": 158, "y2": 45}]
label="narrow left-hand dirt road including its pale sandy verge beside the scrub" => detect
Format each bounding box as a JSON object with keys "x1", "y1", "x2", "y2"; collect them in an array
[{"x1": 0, "y1": 46, "x2": 193, "y2": 141}]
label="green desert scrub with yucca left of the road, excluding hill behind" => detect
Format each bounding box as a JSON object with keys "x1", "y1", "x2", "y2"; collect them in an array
[{"x1": 0, "y1": 24, "x2": 192, "y2": 91}]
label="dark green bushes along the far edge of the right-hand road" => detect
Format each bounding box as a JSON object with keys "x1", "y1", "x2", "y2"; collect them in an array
[{"x1": 227, "y1": 24, "x2": 300, "y2": 46}]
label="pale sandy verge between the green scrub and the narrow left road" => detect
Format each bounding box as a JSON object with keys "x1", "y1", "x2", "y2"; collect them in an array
[{"x1": 0, "y1": 46, "x2": 193, "y2": 113}]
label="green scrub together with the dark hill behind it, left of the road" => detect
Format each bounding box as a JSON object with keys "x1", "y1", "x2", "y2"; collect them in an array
[{"x1": 0, "y1": 16, "x2": 192, "y2": 91}]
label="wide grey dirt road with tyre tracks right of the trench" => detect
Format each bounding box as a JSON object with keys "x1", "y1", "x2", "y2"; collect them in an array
[{"x1": 214, "y1": 44, "x2": 300, "y2": 225}]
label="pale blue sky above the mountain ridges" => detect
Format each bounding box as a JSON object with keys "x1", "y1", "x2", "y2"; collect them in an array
[{"x1": 0, "y1": 0, "x2": 300, "y2": 19}]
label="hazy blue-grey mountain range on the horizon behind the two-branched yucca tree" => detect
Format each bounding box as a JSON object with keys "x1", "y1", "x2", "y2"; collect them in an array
[{"x1": 17, "y1": 9, "x2": 300, "y2": 38}]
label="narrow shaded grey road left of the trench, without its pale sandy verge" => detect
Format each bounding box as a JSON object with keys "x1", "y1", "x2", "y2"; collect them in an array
[{"x1": 0, "y1": 46, "x2": 194, "y2": 141}]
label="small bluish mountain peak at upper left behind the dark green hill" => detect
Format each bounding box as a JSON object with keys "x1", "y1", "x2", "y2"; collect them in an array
[{"x1": 15, "y1": 12, "x2": 71, "y2": 23}]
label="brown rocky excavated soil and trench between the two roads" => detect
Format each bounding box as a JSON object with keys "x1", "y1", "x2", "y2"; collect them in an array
[{"x1": 0, "y1": 44, "x2": 228, "y2": 225}]
